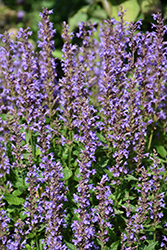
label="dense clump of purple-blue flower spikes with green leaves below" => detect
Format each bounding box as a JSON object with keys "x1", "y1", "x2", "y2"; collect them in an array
[{"x1": 0, "y1": 8, "x2": 167, "y2": 250}]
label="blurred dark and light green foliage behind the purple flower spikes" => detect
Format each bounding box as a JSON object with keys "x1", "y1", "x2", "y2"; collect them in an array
[{"x1": 0, "y1": 0, "x2": 167, "y2": 59}]
